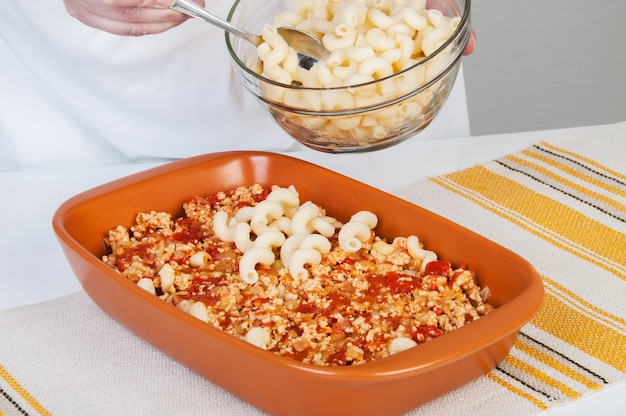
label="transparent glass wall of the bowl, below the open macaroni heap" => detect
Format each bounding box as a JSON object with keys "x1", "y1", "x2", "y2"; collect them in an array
[{"x1": 226, "y1": 0, "x2": 471, "y2": 153}]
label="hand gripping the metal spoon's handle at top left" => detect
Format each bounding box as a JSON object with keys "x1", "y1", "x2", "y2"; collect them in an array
[{"x1": 63, "y1": 0, "x2": 205, "y2": 36}]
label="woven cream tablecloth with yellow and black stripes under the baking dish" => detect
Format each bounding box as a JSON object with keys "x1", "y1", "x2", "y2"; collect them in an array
[{"x1": 0, "y1": 123, "x2": 626, "y2": 416}]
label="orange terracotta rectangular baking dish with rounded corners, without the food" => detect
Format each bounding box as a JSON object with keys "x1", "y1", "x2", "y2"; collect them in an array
[{"x1": 53, "y1": 152, "x2": 543, "y2": 416}]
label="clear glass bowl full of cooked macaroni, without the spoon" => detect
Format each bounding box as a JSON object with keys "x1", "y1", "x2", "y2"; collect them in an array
[{"x1": 226, "y1": 0, "x2": 471, "y2": 153}]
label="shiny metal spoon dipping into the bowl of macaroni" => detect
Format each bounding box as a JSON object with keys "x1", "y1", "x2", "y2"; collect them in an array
[{"x1": 170, "y1": 0, "x2": 330, "y2": 69}]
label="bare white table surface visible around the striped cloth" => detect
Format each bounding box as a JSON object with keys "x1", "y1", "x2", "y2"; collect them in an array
[{"x1": 0, "y1": 129, "x2": 626, "y2": 416}]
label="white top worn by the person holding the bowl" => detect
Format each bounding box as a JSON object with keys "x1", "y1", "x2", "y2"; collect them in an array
[{"x1": 0, "y1": 0, "x2": 469, "y2": 171}]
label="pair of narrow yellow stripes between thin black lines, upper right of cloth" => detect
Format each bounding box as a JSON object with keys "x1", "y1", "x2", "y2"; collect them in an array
[{"x1": 506, "y1": 150, "x2": 626, "y2": 213}]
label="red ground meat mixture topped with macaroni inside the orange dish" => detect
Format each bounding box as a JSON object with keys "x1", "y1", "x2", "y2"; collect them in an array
[{"x1": 103, "y1": 184, "x2": 493, "y2": 366}]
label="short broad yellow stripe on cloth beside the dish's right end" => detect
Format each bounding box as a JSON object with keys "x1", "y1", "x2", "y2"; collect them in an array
[{"x1": 531, "y1": 291, "x2": 626, "y2": 371}]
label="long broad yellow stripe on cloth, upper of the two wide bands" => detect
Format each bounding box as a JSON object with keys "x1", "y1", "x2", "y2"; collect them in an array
[{"x1": 430, "y1": 165, "x2": 626, "y2": 280}]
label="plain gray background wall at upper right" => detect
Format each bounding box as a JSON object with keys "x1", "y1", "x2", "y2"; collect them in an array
[{"x1": 463, "y1": 0, "x2": 626, "y2": 135}]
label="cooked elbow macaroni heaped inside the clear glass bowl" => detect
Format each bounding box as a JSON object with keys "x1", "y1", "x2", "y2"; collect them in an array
[{"x1": 248, "y1": 0, "x2": 460, "y2": 147}]
